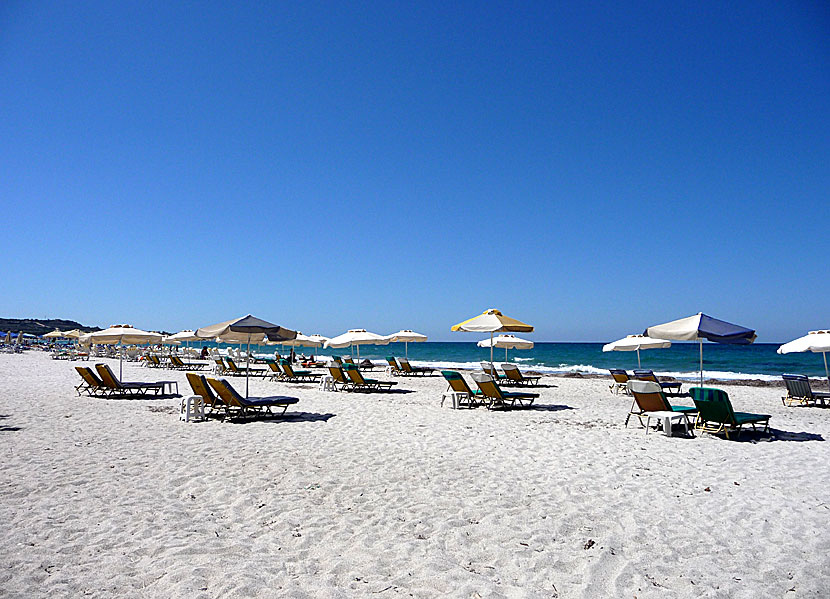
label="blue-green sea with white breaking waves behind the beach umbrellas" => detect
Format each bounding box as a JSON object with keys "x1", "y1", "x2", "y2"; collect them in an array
[{"x1": 203, "y1": 342, "x2": 825, "y2": 380}]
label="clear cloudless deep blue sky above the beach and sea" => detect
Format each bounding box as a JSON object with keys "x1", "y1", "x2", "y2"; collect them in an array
[{"x1": 0, "y1": 1, "x2": 830, "y2": 341}]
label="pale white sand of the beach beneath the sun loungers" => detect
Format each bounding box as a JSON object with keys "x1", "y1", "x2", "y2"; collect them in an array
[{"x1": 0, "y1": 352, "x2": 830, "y2": 598}]
